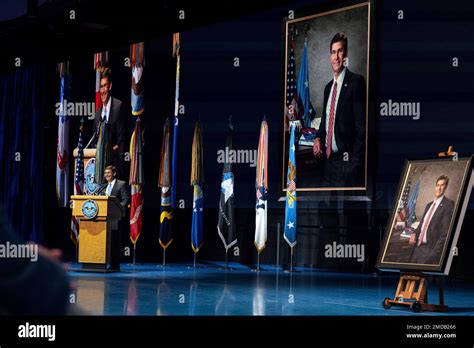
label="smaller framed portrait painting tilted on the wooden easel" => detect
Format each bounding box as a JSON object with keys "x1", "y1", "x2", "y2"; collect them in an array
[{"x1": 377, "y1": 157, "x2": 474, "y2": 275}]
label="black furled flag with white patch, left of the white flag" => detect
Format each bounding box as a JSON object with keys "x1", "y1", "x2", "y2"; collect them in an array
[{"x1": 217, "y1": 118, "x2": 237, "y2": 254}]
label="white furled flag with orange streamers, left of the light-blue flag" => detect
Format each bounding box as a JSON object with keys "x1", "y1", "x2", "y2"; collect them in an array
[{"x1": 254, "y1": 120, "x2": 268, "y2": 254}]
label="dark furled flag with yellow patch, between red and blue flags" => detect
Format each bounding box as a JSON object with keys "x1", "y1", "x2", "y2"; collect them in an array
[{"x1": 158, "y1": 118, "x2": 173, "y2": 249}]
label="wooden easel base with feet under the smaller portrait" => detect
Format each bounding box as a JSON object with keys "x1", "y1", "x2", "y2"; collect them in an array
[{"x1": 382, "y1": 273, "x2": 448, "y2": 312}]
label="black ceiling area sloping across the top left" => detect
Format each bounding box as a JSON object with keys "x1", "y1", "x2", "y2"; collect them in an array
[{"x1": 0, "y1": 0, "x2": 294, "y2": 68}]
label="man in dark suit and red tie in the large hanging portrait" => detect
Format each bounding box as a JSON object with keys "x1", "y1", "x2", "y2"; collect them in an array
[{"x1": 313, "y1": 33, "x2": 367, "y2": 187}]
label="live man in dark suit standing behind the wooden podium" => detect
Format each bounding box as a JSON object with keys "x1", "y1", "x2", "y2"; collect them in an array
[{"x1": 100, "y1": 166, "x2": 130, "y2": 271}]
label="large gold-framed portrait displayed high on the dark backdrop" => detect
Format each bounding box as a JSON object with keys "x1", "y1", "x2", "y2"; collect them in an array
[{"x1": 282, "y1": 1, "x2": 373, "y2": 195}]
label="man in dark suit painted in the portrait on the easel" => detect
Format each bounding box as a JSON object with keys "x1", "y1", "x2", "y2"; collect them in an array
[{"x1": 409, "y1": 175, "x2": 454, "y2": 264}]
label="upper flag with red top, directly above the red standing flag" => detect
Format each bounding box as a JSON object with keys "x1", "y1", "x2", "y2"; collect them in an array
[{"x1": 130, "y1": 42, "x2": 145, "y2": 116}]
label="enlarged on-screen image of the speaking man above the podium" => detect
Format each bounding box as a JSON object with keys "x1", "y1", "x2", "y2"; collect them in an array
[{"x1": 94, "y1": 68, "x2": 127, "y2": 175}]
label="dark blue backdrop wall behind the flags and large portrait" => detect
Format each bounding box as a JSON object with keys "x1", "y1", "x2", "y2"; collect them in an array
[{"x1": 33, "y1": 1, "x2": 474, "y2": 272}]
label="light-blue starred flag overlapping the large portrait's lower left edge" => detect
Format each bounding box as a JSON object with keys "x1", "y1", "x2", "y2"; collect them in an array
[{"x1": 285, "y1": 125, "x2": 296, "y2": 248}]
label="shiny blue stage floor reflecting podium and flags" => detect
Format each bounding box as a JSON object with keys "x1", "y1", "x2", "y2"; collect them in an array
[{"x1": 69, "y1": 262, "x2": 474, "y2": 316}]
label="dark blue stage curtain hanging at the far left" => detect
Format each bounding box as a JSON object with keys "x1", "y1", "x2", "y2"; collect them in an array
[{"x1": 0, "y1": 65, "x2": 45, "y2": 243}]
